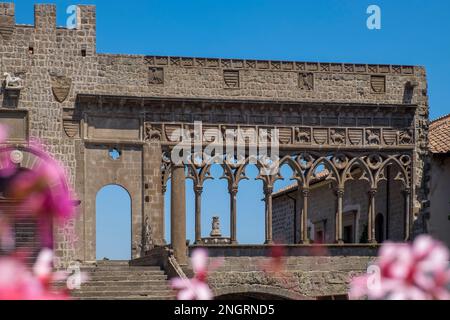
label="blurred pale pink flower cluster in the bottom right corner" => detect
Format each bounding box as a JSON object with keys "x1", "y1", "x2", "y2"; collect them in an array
[{"x1": 349, "y1": 235, "x2": 450, "y2": 300}]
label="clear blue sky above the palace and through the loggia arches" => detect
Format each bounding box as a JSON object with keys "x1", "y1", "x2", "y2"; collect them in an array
[{"x1": 13, "y1": 0, "x2": 450, "y2": 258}]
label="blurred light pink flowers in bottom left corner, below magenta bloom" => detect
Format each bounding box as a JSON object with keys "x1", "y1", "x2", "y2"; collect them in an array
[{"x1": 0, "y1": 249, "x2": 69, "y2": 300}]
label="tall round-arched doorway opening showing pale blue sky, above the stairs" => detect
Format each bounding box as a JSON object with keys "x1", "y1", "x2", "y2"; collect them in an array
[{"x1": 95, "y1": 185, "x2": 132, "y2": 260}]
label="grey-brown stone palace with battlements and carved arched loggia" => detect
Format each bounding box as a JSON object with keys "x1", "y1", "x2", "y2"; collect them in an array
[{"x1": 0, "y1": 3, "x2": 428, "y2": 297}]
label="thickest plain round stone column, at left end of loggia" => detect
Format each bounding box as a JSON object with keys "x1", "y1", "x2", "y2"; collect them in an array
[{"x1": 170, "y1": 164, "x2": 187, "y2": 265}]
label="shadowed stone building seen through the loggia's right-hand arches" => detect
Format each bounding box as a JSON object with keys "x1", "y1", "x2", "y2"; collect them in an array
[{"x1": 272, "y1": 169, "x2": 405, "y2": 244}]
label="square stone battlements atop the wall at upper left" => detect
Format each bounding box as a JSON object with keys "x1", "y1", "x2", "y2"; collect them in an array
[{"x1": 0, "y1": 2, "x2": 96, "y2": 34}]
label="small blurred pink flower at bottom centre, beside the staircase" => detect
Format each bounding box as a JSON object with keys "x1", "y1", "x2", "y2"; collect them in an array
[{"x1": 171, "y1": 249, "x2": 218, "y2": 300}]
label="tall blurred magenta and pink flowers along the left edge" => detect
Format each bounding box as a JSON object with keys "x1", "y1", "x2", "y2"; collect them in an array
[{"x1": 0, "y1": 126, "x2": 79, "y2": 300}]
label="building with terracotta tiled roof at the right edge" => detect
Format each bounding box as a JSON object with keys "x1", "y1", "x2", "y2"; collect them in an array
[{"x1": 429, "y1": 115, "x2": 450, "y2": 247}]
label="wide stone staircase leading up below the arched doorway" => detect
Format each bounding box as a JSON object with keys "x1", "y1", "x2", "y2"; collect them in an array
[{"x1": 67, "y1": 261, "x2": 175, "y2": 300}]
